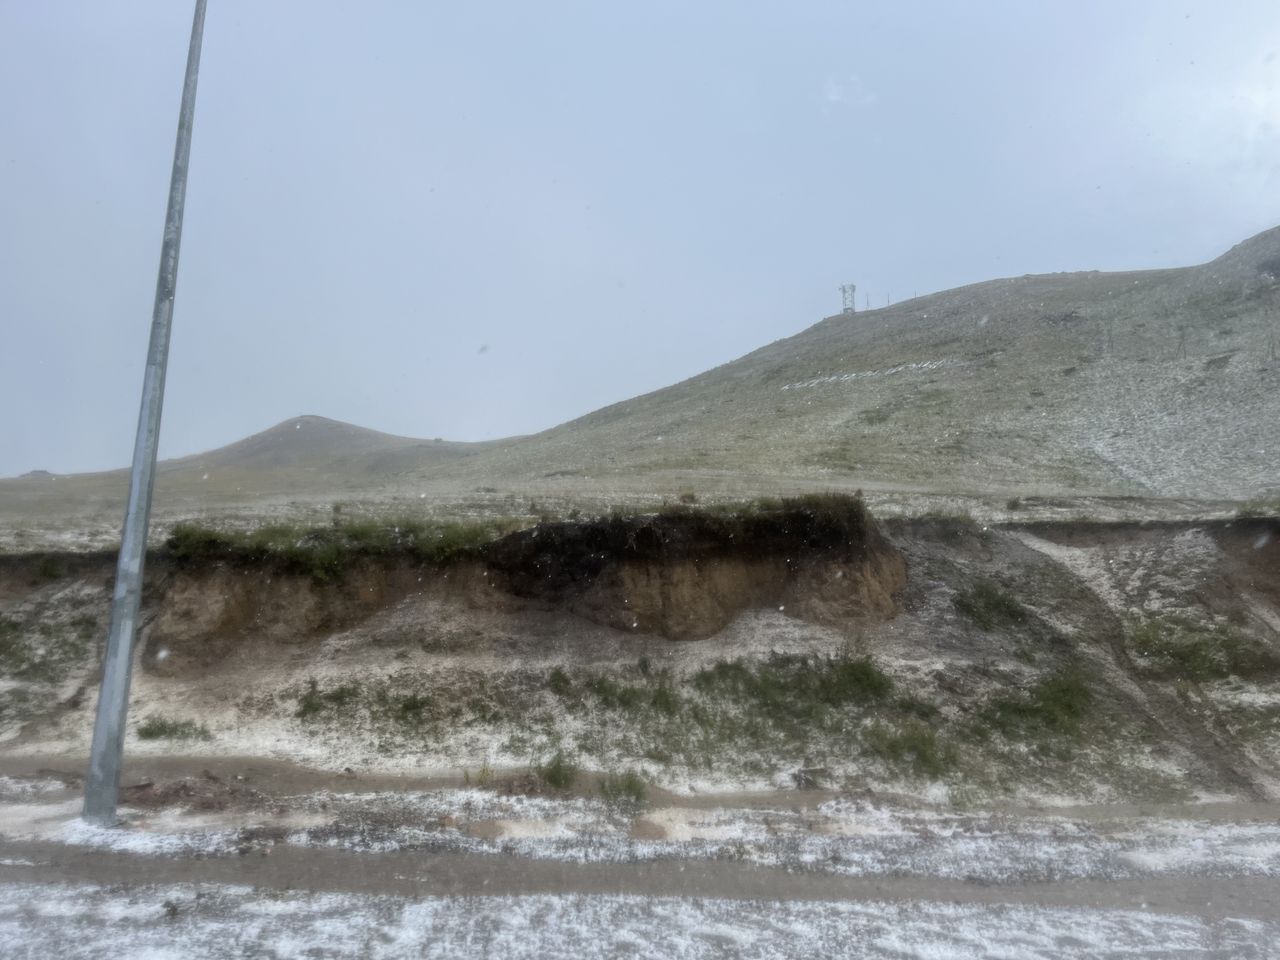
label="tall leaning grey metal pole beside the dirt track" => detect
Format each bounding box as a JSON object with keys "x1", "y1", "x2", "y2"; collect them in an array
[{"x1": 84, "y1": 0, "x2": 206, "y2": 824}]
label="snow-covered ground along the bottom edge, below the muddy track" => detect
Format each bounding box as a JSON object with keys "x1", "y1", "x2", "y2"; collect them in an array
[{"x1": 0, "y1": 883, "x2": 1280, "y2": 960}]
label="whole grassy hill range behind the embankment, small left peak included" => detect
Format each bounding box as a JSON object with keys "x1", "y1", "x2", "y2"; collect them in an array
[{"x1": 0, "y1": 228, "x2": 1280, "y2": 542}]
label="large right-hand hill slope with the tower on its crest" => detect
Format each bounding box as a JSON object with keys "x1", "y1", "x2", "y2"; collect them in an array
[{"x1": 449, "y1": 221, "x2": 1280, "y2": 498}]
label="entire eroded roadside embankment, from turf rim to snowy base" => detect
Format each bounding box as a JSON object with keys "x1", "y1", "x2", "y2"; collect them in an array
[{"x1": 0, "y1": 512, "x2": 1280, "y2": 803}]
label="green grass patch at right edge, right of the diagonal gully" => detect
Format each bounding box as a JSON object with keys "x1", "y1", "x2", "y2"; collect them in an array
[{"x1": 1129, "y1": 617, "x2": 1280, "y2": 682}]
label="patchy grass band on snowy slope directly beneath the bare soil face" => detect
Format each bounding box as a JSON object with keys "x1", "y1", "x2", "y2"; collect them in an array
[{"x1": 285, "y1": 654, "x2": 951, "y2": 797}]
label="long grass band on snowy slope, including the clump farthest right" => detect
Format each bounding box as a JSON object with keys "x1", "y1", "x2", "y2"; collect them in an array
[{"x1": 267, "y1": 632, "x2": 1172, "y2": 803}]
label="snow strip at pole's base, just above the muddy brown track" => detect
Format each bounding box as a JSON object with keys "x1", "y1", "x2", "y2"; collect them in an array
[{"x1": 0, "y1": 790, "x2": 1280, "y2": 883}]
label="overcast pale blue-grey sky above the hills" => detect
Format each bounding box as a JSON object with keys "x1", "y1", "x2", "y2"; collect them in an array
[{"x1": 0, "y1": 0, "x2": 1280, "y2": 475}]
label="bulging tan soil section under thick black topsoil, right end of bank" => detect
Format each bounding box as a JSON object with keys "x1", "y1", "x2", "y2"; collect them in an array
[{"x1": 485, "y1": 497, "x2": 906, "y2": 640}]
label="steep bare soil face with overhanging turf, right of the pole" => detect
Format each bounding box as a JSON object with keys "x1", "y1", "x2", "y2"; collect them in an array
[{"x1": 147, "y1": 500, "x2": 906, "y2": 671}]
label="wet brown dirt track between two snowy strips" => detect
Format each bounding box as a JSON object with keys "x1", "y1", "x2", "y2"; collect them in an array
[{"x1": 0, "y1": 841, "x2": 1280, "y2": 920}]
